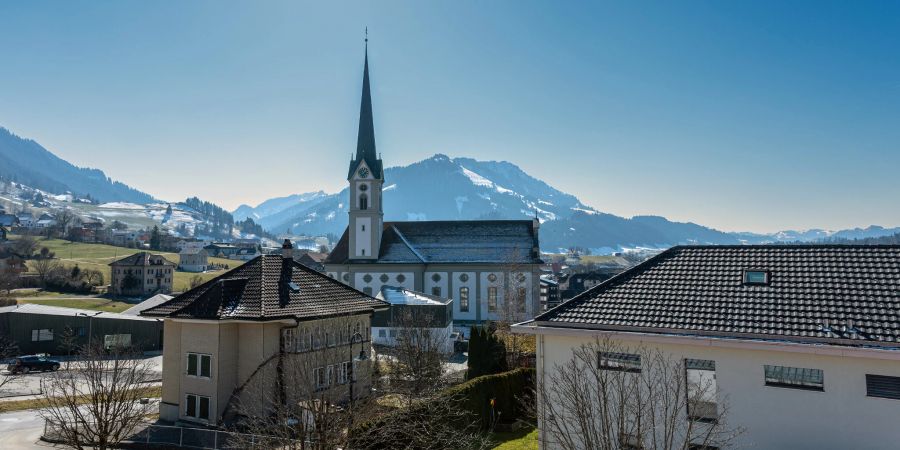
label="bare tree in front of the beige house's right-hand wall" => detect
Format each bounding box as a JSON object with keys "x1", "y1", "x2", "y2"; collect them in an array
[{"x1": 229, "y1": 317, "x2": 370, "y2": 450}]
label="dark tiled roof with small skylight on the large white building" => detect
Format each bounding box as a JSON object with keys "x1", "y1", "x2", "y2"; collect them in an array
[{"x1": 535, "y1": 245, "x2": 900, "y2": 346}]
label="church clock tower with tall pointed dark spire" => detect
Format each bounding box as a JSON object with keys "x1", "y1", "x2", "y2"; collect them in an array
[{"x1": 347, "y1": 37, "x2": 384, "y2": 260}]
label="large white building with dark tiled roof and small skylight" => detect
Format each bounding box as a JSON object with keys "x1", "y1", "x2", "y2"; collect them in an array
[{"x1": 514, "y1": 245, "x2": 900, "y2": 449}]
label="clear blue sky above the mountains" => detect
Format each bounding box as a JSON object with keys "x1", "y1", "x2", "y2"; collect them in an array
[{"x1": 0, "y1": 0, "x2": 900, "y2": 231}]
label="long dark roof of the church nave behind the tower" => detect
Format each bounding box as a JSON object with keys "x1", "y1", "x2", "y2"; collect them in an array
[{"x1": 325, "y1": 220, "x2": 541, "y2": 264}]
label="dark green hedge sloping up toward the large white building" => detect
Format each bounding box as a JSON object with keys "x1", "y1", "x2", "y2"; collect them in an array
[{"x1": 350, "y1": 368, "x2": 534, "y2": 449}]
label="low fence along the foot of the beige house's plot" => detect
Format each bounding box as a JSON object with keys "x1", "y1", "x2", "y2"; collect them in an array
[{"x1": 41, "y1": 420, "x2": 297, "y2": 450}]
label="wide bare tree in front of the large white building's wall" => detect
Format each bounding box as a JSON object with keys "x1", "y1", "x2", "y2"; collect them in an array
[{"x1": 535, "y1": 339, "x2": 742, "y2": 450}]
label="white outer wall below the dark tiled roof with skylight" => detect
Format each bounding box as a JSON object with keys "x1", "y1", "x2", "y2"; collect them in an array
[{"x1": 515, "y1": 326, "x2": 900, "y2": 449}]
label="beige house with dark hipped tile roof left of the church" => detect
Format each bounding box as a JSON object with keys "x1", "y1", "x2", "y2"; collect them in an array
[{"x1": 141, "y1": 242, "x2": 387, "y2": 425}]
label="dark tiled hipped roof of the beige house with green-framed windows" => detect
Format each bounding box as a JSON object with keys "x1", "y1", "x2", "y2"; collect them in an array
[{"x1": 141, "y1": 255, "x2": 387, "y2": 320}]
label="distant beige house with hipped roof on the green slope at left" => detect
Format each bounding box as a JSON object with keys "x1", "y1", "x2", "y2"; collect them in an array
[{"x1": 109, "y1": 252, "x2": 175, "y2": 296}]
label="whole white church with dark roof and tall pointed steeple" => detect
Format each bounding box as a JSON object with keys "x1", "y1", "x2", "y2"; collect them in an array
[{"x1": 325, "y1": 44, "x2": 542, "y2": 335}]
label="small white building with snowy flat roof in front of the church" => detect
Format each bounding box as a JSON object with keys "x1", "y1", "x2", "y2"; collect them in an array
[{"x1": 372, "y1": 286, "x2": 453, "y2": 354}]
